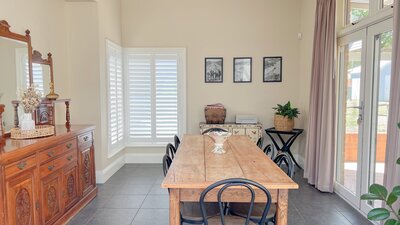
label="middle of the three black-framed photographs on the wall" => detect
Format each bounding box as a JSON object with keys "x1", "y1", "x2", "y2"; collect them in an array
[{"x1": 233, "y1": 57, "x2": 252, "y2": 83}]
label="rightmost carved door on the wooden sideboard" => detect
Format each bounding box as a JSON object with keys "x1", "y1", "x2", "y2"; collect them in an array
[{"x1": 80, "y1": 147, "x2": 94, "y2": 195}]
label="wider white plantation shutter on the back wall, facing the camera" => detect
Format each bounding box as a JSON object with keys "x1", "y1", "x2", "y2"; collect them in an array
[{"x1": 125, "y1": 49, "x2": 185, "y2": 145}]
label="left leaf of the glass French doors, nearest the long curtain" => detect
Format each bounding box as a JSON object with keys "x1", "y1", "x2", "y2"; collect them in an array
[{"x1": 335, "y1": 30, "x2": 366, "y2": 205}]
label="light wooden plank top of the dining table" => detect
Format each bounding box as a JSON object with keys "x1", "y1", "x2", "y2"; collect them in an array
[{"x1": 161, "y1": 135, "x2": 298, "y2": 189}]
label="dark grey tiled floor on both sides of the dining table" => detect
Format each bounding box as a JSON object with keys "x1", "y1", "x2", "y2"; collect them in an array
[{"x1": 68, "y1": 164, "x2": 372, "y2": 225}]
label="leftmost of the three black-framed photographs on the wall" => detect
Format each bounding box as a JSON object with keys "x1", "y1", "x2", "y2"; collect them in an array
[{"x1": 205, "y1": 57, "x2": 224, "y2": 83}]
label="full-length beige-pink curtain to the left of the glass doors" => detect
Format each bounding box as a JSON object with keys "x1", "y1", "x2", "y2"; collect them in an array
[{"x1": 304, "y1": 0, "x2": 336, "y2": 192}]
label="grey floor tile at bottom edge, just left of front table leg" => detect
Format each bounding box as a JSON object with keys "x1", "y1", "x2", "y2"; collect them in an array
[{"x1": 132, "y1": 209, "x2": 169, "y2": 225}]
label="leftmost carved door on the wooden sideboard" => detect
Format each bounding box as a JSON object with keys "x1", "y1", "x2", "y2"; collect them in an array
[{"x1": 6, "y1": 170, "x2": 36, "y2": 225}]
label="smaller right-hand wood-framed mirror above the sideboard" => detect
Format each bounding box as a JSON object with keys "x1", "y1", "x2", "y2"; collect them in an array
[{"x1": 32, "y1": 50, "x2": 58, "y2": 100}]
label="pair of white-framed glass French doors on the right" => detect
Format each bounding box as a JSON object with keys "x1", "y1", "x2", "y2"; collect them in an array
[{"x1": 335, "y1": 19, "x2": 392, "y2": 212}]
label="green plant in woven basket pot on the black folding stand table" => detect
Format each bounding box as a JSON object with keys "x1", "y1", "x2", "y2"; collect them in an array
[{"x1": 273, "y1": 101, "x2": 300, "y2": 131}]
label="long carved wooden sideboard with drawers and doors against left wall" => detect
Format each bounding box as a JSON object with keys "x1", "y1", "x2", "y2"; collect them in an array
[{"x1": 0, "y1": 126, "x2": 97, "y2": 225}]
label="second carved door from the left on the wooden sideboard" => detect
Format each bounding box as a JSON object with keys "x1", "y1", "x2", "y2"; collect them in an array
[{"x1": 41, "y1": 171, "x2": 62, "y2": 224}]
